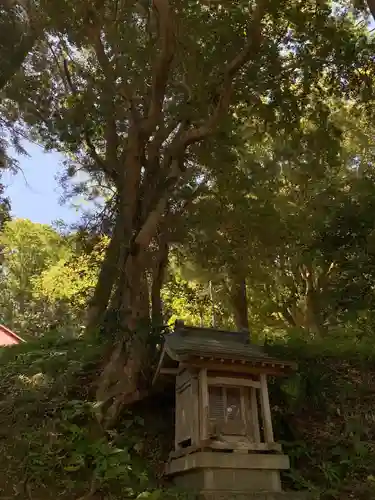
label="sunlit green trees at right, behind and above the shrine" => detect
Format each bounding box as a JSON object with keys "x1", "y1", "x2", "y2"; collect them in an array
[{"x1": 179, "y1": 95, "x2": 374, "y2": 335}]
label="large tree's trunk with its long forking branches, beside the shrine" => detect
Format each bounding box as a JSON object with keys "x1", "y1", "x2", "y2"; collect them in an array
[{"x1": 86, "y1": 0, "x2": 266, "y2": 428}]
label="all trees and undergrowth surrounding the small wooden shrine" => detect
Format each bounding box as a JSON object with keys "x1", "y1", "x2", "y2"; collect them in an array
[{"x1": 0, "y1": 0, "x2": 375, "y2": 500}]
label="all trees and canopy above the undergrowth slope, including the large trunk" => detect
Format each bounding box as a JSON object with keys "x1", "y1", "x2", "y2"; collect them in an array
[{"x1": 0, "y1": 0, "x2": 375, "y2": 426}]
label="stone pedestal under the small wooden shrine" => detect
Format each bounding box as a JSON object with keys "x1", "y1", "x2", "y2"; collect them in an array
[{"x1": 166, "y1": 452, "x2": 289, "y2": 500}]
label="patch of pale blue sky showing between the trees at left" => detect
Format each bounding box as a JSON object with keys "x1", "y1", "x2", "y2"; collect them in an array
[{"x1": 2, "y1": 143, "x2": 79, "y2": 224}]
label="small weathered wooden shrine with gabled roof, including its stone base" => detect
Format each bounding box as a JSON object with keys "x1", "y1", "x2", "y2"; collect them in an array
[{"x1": 154, "y1": 321, "x2": 295, "y2": 495}]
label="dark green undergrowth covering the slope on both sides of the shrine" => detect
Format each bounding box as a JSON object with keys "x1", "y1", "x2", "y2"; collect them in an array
[{"x1": 0, "y1": 333, "x2": 375, "y2": 500}]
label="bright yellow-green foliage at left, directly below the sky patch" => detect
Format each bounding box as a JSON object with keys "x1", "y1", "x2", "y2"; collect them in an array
[{"x1": 0, "y1": 219, "x2": 88, "y2": 336}]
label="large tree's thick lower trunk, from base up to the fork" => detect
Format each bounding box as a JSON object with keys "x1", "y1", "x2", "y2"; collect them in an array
[{"x1": 96, "y1": 180, "x2": 159, "y2": 428}]
